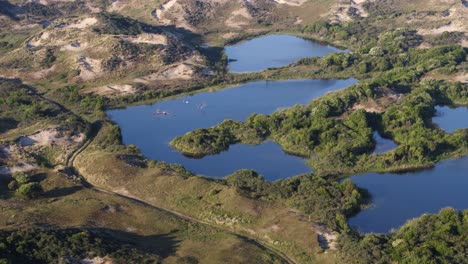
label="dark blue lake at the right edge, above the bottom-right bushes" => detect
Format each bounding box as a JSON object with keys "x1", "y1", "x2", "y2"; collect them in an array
[{"x1": 349, "y1": 157, "x2": 468, "y2": 233}]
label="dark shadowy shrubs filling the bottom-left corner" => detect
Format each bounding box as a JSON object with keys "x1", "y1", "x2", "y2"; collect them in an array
[{"x1": 0, "y1": 228, "x2": 160, "y2": 263}]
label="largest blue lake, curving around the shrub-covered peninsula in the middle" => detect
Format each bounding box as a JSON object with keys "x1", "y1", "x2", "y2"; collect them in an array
[{"x1": 107, "y1": 79, "x2": 356, "y2": 180}]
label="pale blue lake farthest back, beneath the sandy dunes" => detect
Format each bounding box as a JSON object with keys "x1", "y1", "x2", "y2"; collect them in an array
[{"x1": 225, "y1": 35, "x2": 343, "y2": 72}]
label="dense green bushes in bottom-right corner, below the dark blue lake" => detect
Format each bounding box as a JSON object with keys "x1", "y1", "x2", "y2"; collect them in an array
[{"x1": 340, "y1": 208, "x2": 468, "y2": 264}]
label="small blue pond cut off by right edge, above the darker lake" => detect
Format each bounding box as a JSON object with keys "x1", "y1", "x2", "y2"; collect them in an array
[{"x1": 432, "y1": 106, "x2": 468, "y2": 133}]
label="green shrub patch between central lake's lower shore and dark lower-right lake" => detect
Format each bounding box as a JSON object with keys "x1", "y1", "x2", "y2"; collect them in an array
[{"x1": 223, "y1": 170, "x2": 369, "y2": 230}]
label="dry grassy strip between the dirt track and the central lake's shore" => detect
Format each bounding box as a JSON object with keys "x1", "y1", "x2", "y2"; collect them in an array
[{"x1": 75, "y1": 125, "x2": 340, "y2": 261}]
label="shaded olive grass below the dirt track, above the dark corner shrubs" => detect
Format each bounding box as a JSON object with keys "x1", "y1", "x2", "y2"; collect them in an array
[{"x1": 0, "y1": 168, "x2": 286, "y2": 264}]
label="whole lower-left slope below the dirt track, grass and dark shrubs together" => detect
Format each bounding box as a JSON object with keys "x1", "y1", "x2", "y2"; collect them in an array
[{"x1": 0, "y1": 170, "x2": 288, "y2": 264}]
